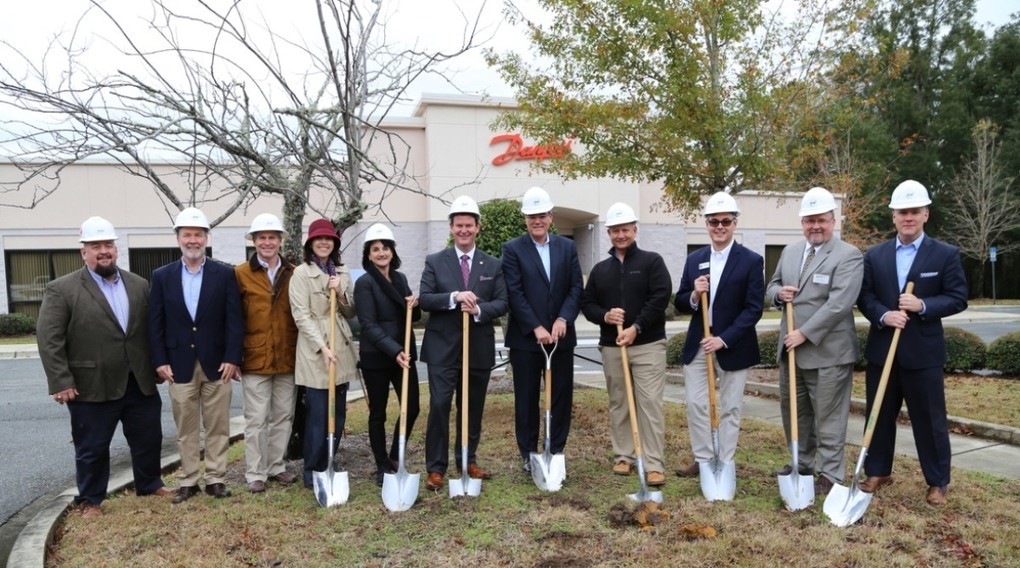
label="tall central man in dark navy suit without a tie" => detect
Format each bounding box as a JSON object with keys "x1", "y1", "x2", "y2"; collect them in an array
[{"x1": 500, "y1": 188, "x2": 583, "y2": 473}]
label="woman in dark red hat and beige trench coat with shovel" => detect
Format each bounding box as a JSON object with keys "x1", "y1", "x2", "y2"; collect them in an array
[{"x1": 291, "y1": 219, "x2": 358, "y2": 488}]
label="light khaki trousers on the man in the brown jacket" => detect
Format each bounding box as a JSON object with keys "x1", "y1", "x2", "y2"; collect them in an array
[{"x1": 241, "y1": 373, "x2": 295, "y2": 483}]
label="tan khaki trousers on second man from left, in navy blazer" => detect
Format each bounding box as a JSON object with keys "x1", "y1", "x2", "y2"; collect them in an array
[{"x1": 170, "y1": 361, "x2": 231, "y2": 487}]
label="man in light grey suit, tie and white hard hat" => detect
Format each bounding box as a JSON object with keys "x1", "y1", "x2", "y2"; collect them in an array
[{"x1": 766, "y1": 188, "x2": 864, "y2": 498}]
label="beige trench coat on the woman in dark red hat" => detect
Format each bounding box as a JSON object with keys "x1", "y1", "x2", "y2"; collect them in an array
[{"x1": 291, "y1": 262, "x2": 358, "y2": 390}]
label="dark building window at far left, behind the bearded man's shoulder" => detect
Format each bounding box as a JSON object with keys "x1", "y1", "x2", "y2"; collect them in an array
[{"x1": 4, "y1": 249, "x2": 83, "y2": 317}]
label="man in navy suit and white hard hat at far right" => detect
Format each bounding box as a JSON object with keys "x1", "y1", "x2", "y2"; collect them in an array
[{"x1": 857, "y1": 179, "x2": 968, "y2": 505}]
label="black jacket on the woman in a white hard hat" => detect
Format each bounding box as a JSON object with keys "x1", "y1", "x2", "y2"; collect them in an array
[{"x1": 354, "y1": 267, "x2": 421, "y2": 369}]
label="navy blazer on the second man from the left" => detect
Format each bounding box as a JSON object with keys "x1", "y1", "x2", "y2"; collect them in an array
[{"x1": 149, "y1": 258, "x2": 244, "y2": 382}]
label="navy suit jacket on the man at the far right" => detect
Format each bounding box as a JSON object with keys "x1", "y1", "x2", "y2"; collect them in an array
[{"x1": 857, "y1": 235, "x2": 967, "y2": 369}]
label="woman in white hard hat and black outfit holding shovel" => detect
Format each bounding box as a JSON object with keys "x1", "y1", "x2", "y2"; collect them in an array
[{"x1": 354, "y1": 223, "x2": 421, "y2": 486}]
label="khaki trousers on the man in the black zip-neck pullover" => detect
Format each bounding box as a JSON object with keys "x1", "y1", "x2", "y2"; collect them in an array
[{"x1": 599, "y1": 340, "x2": 666, "y2": 472}]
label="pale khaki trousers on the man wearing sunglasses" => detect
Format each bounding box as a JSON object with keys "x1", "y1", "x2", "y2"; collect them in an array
[{"x1": 683, "y1": 349, "x2": 748, "y2": 463}]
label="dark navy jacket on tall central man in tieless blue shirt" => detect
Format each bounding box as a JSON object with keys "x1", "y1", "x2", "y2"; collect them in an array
[{"x1": 500, "y1": 234, "x2": 584, "y2": 351}]
